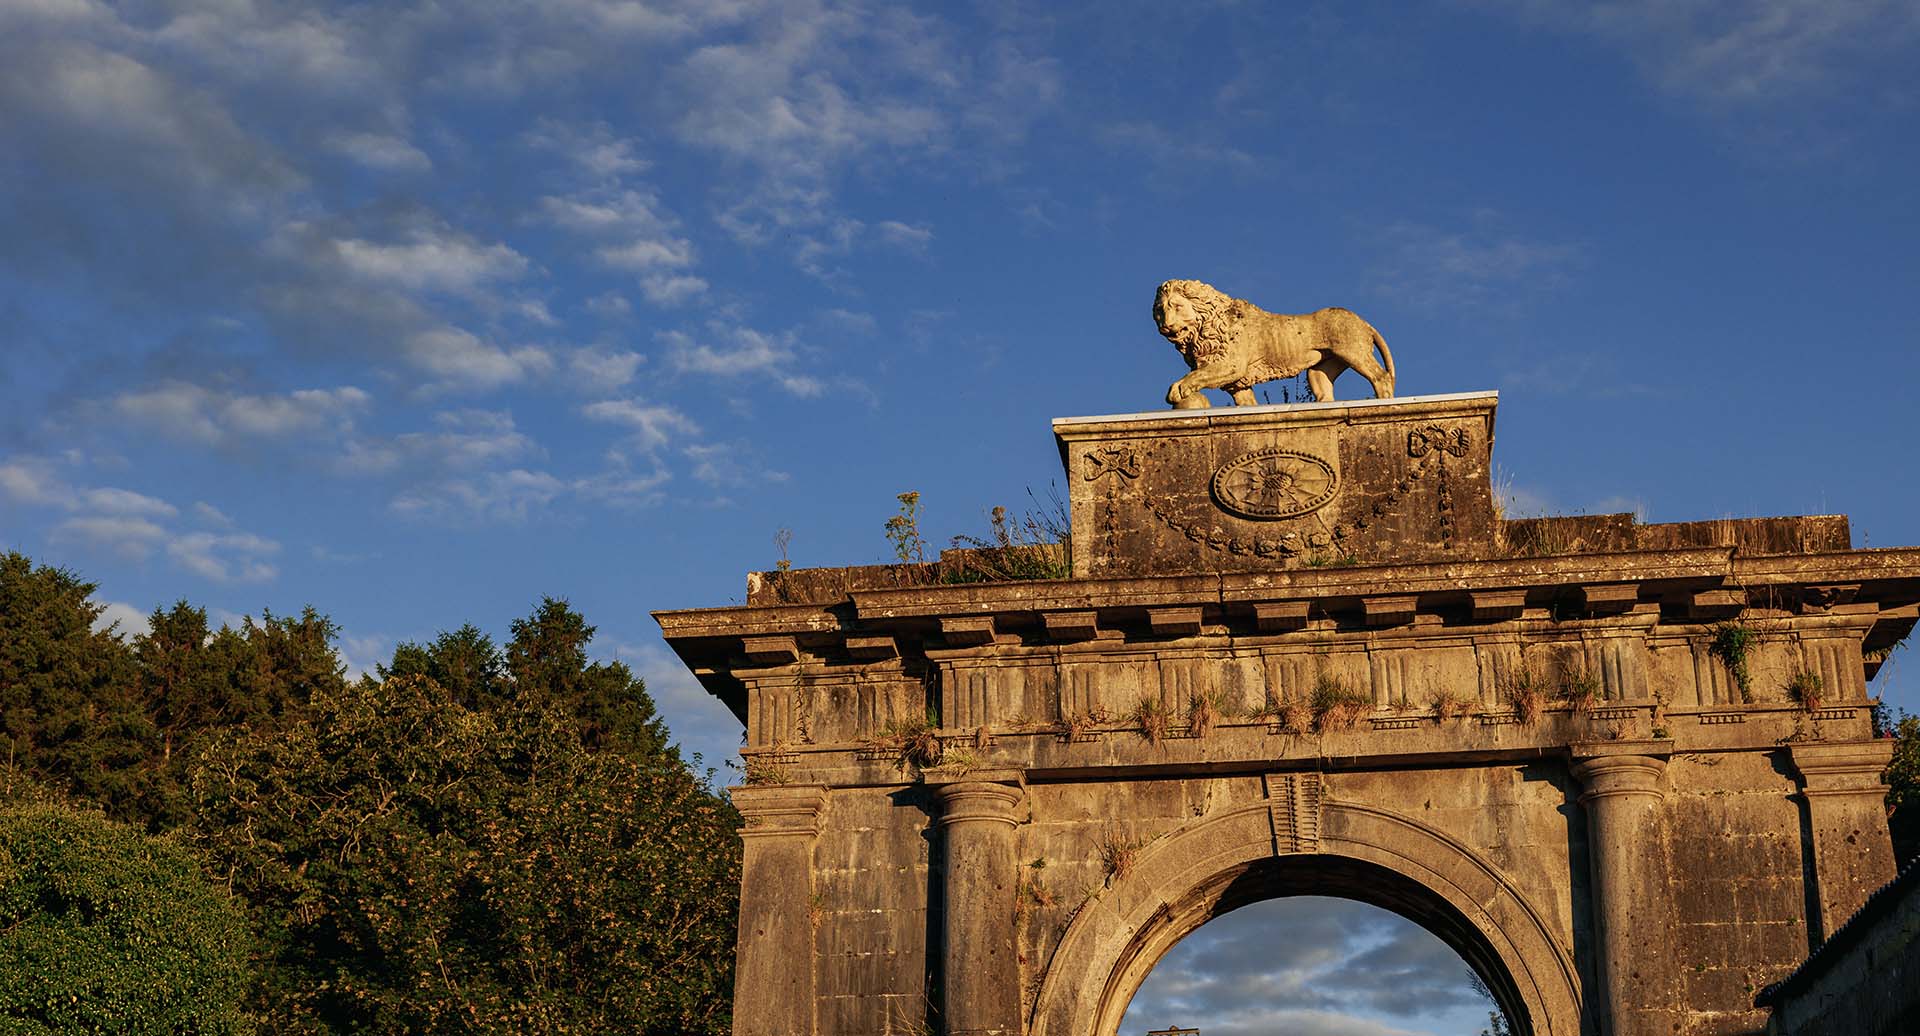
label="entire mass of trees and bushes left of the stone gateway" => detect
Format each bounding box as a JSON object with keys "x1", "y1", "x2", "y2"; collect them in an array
[{"x1": 0, "y1": 554, "x2": 739, "y2": 1034}]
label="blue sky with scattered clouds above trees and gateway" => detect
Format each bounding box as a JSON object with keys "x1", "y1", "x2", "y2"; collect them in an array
[{"x1": 0, "y1": 0, "x2": 1920, "y2": 1028}]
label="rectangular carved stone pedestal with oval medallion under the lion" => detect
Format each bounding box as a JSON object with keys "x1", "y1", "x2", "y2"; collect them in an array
[{"x1": 1054, "y1": 391, "x2": 1500, "y2": 577}]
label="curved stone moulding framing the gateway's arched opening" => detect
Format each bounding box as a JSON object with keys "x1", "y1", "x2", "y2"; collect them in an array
[{"x1": 1027, "y1": 802, "x2": 1582, "y2": 1036}]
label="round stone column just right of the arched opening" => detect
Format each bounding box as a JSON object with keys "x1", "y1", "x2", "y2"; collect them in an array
[{"x1": 1572, "y1": 741, "x2": 1678, "y2": 1036}]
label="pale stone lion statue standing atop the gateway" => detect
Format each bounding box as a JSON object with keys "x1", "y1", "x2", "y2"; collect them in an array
[{"x1": 1154, "y1": 280, "x2": 1394, "y2": 411}]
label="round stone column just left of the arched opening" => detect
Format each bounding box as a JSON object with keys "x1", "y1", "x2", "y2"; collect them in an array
[{"x1": 929, "y1": 771, "x2": 1025, "y2": 1036}]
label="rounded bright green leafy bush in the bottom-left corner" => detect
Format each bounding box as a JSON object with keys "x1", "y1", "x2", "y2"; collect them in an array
[{"x1": 0, "y1": 773, "x2": 252, "y2": 1036}]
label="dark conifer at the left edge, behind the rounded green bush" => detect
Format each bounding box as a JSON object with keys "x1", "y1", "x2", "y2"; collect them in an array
[{"x1": 0, "y1": 553, "x2": 156, "y2": 815}]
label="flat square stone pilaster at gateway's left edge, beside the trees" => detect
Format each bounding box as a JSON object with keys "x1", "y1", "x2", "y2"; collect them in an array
[{"x1": 730, "y1": 785, "x2": 828, "y2": 1036}]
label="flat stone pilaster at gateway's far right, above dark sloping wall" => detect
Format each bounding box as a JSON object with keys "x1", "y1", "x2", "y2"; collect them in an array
[{"x1": 1788, "y1": 741, "x2": 1895, "y2": 940}]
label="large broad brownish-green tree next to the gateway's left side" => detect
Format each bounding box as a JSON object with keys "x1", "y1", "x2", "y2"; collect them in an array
[{"x1": 194, "y1": 675, "x2": 739, "y2": 1034}]
